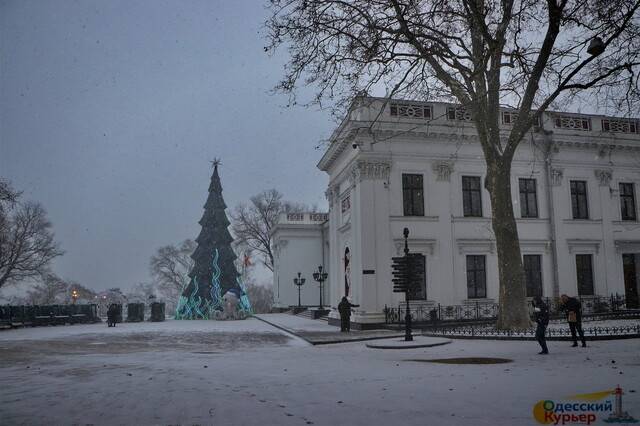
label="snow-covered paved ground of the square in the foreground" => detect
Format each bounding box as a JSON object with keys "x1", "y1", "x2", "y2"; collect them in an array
[{"x1": 0, "y1": 314, "x2": 640, "y2": 425}]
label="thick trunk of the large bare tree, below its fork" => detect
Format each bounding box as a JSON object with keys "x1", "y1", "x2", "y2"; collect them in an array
[{"x1": 485, "y1": 160, "x2": 531, "y2": 330}]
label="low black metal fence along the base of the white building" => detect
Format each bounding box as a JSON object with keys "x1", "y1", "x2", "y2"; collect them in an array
[{"x1": 384, "y1": 294, "x2": 638, "y2": 325}]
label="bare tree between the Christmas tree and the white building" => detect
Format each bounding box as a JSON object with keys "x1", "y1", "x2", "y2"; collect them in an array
[{"x1": 229, "y1": 189, "x2": 305, "y2": 271}]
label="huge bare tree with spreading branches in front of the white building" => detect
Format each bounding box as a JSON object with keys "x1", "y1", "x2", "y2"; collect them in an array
[{"x1": 267, "y1": 0, "x2": 640, "y2": 329}]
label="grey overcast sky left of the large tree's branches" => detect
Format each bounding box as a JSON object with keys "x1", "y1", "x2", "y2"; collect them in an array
[{"x1": 0, "y1": 0, "x2": 335, "y2": 291}]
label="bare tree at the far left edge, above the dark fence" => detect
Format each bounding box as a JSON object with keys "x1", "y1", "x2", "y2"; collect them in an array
[{"x1": 0, "y1": 202, "x2": 64, "y2": 287}]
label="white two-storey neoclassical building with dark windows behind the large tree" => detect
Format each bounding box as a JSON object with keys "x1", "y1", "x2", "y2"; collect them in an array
[{"x1": 274, "y1": 98, "x2": 640, "y2": 327}]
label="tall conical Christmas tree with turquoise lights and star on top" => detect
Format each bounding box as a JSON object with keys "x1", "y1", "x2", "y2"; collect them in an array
[{"x1": 174, "y1": 159, "x2": 253, "y2": 319}]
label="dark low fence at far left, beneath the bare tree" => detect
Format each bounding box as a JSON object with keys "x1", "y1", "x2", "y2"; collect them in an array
[{"x1": 0, "y1": 304, "x2": 101, "y2": 329}]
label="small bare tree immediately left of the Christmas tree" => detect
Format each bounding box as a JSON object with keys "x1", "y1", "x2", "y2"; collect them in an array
[{"x1": 149, "y1": 239, "x2": 196, "y2": 298}]
